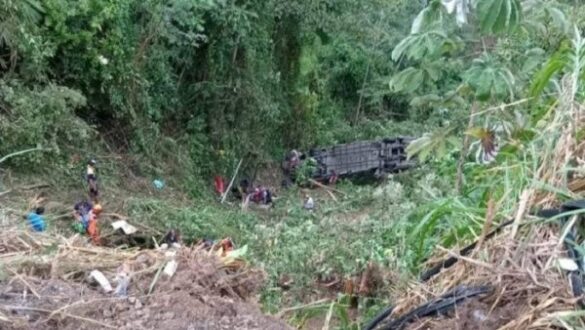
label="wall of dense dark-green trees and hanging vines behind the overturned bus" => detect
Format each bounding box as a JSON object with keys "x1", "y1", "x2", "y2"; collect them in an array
[{"x1": 0, "y1": 0, "x2": 421, "y2": 184}]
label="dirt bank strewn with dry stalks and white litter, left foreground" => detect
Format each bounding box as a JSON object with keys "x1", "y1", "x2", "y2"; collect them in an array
[{"x1": 0, "y1": 230, "x2": 289, "y2": 330}]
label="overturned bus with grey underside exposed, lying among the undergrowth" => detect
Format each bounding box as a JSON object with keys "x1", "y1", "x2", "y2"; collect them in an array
[{"x1": 282, "y1": 137, "x2": 416, "y2": 183}]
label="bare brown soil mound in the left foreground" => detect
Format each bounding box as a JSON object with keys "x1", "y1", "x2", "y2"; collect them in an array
[{"x1": 0, "y1": 251, "x2": 290, "y2": 330}]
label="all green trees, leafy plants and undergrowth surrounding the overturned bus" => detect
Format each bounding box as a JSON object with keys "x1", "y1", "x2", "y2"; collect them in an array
[{"x1": 0, "y1": 0, "x2": 585, "y2": 328}]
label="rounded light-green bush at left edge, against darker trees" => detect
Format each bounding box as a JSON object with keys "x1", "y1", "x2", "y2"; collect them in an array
[{"x1": 0, "y1": 80, "x2": 94, "y2": 165}]
